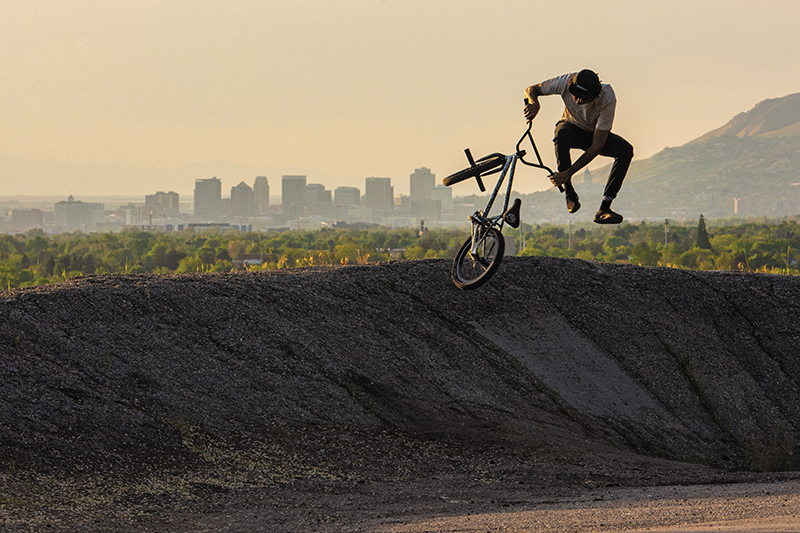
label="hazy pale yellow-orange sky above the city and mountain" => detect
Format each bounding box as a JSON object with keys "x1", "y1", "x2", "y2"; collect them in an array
[{"x1": 0, "y1": 0, "x2": 800, "y2": 197}]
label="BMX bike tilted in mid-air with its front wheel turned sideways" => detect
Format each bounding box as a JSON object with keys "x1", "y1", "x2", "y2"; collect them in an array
[{"x1": 443, "y1": 110, "x2": 564, "y2": 289}]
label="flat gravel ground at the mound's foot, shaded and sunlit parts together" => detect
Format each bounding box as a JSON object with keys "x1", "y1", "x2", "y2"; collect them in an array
[{"x1": 29, "y1": 479, "x2": 800, "y2": 533}]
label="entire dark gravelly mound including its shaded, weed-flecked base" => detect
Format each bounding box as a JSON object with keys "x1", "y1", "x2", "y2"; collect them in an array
[{"x1": 0, "y1": 258, "x2": 800, "y2": 531}]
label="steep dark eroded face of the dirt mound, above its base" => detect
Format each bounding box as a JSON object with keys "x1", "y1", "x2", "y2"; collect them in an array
[{"x1": 0, "y1": 258, "x2": 800, "y2": 470}]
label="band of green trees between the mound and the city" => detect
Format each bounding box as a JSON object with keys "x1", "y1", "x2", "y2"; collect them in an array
[{"x1": 0, "y1": 215, "x2": 800, "y2": 290}]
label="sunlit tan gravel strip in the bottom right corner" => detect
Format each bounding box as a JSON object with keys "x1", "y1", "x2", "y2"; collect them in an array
[{"x1": 372, "y1": 482, "x2": 800, "y2": 533}]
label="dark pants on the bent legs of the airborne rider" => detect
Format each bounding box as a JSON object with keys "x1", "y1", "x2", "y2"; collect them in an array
[{"x1": 553, "y1": 121, "x2": 633, "y2": 198}]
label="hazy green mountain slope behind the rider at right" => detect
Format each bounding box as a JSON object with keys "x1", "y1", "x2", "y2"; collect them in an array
[{"x1": 523, "y1": 93, "x2": 800, "y2": 219}]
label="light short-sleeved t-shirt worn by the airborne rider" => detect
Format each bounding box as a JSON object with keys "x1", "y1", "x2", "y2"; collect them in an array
[{"x1": 541, "y1": 72, "x2": 617, "y2": 131}]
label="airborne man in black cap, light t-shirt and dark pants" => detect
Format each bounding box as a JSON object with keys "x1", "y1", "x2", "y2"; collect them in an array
[{"x1": 524, "y1": 69, "x2": 633, "y2": 224}]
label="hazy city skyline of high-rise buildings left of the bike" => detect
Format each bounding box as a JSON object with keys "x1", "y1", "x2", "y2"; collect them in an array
[{"x1": 0, "y1": 167, "x2": 456, "y2": 233}]
